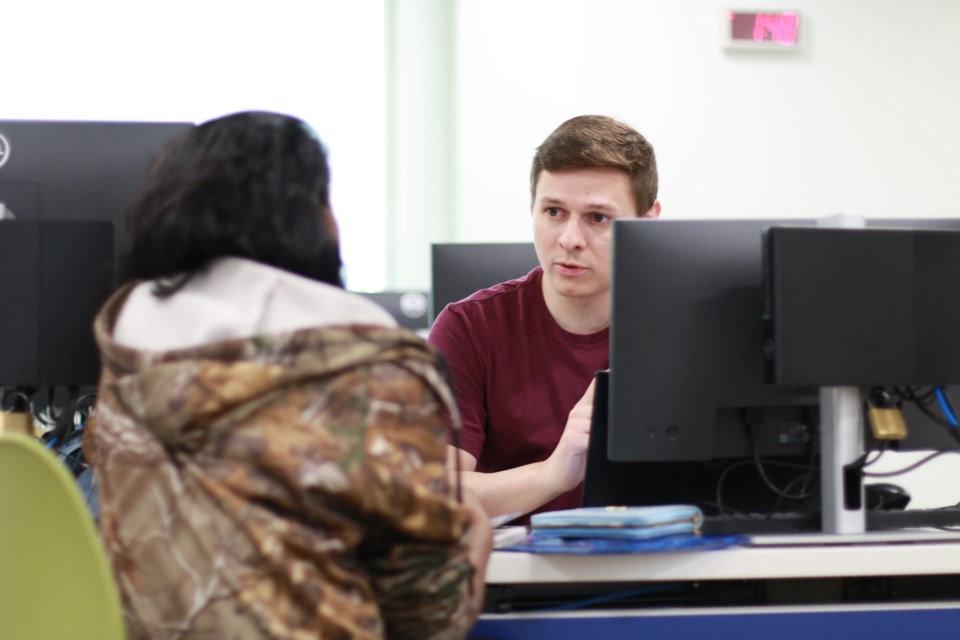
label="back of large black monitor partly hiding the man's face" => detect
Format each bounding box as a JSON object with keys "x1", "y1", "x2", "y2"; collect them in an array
[{"x1": 609, "y1": 219, "x2": 819, "y2": 462}]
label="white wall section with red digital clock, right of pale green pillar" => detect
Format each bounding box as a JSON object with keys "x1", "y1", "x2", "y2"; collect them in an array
[{"x1": 455, "y1": 0, "x2": 960, "y2": 248}]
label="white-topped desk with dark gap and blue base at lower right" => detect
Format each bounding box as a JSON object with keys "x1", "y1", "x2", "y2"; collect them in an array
[{"x1": 471, "y1": 532, "x2": 960, "y2": 640}]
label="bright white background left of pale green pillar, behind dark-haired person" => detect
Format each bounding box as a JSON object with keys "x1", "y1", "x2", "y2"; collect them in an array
[{"x1": 0, "y1": 0, "x2": 387, "y2": 290}]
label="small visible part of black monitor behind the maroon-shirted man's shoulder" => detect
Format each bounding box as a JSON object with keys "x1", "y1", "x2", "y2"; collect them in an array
[{"x1": 430, "y1": 243, "x2": 540, "y2": 324}]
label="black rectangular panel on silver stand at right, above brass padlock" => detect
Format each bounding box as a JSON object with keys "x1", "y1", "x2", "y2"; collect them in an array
[{"x1": 763, "y1": 226, "x2": 960, "y2": 387}]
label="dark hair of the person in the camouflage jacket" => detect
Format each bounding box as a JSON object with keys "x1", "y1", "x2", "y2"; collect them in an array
[{"x1": 118, "y1": 111, "x2": 343, "y2": 295}]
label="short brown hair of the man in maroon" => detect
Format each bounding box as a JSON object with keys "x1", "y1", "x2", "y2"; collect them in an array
[{"x1": 530, "y1": 115, "x2": 657, "y2": 215}]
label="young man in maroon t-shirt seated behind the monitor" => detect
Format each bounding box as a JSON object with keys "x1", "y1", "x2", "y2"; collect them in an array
[{"x1": 429, "y1": 116, "x2": 660, "y2": 515}]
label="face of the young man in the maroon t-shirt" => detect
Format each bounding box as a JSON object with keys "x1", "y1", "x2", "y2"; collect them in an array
[{"x1": 533, "y1": 167, "x2": 659, "y2": 306}]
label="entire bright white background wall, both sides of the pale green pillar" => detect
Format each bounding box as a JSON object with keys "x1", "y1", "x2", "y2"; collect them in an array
[{"x1": 7, "y1": 0, "x2": 960, "y2": 290}]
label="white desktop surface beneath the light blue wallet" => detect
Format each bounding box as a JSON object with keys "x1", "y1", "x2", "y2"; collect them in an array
[{"x1": 487, "y1": 532, "x2": 960, "y2": 585}]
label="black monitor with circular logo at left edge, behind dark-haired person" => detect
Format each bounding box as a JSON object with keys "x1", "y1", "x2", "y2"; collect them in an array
[{"x1": 0, "y1": 120, "x2": 192, "y2": 387}]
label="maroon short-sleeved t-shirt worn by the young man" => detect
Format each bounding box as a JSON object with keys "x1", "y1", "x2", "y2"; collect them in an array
[{"x1": 428, "y1": 267, "x2": 610, "y2": 511}]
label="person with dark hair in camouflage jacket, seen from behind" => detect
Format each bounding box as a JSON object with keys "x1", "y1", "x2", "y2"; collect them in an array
[{"x1": 84, "y1": 112, "x2": 492, "y2": 638}]
